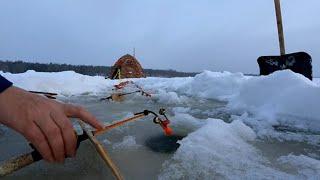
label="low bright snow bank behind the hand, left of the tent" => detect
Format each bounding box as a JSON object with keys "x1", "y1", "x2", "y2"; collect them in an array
[{"x1": 1, "y1": 70, "x2": 116, "y2": 96}]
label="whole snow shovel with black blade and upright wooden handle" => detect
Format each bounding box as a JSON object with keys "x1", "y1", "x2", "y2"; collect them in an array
[{"x1": 257, "y1": 0, "x2": 312, "y2": 80}]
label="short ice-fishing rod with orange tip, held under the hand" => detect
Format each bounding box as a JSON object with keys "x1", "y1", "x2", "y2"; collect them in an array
[{"x1": 0, "y1": 108, "x2": 173, "y2": 177}]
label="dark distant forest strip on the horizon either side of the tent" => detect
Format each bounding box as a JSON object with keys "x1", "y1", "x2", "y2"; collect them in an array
[{"x1": 0, "y1": 60, "x2": 197, "y2": 77}]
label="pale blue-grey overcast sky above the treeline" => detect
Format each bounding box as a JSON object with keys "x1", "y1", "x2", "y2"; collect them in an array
[{"x1": 0, "y1": 0, "x2": 320, "y2": 76}]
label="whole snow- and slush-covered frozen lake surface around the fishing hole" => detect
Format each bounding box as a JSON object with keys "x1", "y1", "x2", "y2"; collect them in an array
[{"x1": 0, "y1": 72, "x2": 320, "y2": 180}]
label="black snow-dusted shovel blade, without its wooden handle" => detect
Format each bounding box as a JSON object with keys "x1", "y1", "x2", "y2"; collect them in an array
[{"x1": 257, "y1": 52, "x2": 312, "y2": 80}]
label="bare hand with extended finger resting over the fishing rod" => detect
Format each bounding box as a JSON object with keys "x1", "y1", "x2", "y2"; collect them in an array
[{"x1": 0, "y1": 87, "x2": 102, "y2": 162}]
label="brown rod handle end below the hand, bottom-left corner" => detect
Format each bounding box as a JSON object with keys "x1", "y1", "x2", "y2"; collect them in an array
[{"x1": 0, "y1": 151, "x2": 42, "y2": 177}]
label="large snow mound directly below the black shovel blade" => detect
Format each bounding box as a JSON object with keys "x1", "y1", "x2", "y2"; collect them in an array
[{"x1": 229, "y1": 71, "x2": 320, "y2": 119}]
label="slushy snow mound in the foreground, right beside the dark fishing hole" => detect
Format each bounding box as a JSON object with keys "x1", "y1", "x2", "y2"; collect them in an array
[{"x1": 159, "y1": 119, "x2": 291, "y2": 179}]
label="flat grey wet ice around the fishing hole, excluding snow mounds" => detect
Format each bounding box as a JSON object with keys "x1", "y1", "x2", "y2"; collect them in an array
[{"x1": 0, "y1": 96, "x2": 320, "y2": 180}]
